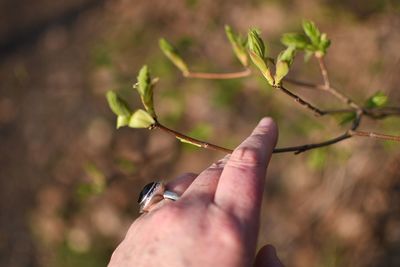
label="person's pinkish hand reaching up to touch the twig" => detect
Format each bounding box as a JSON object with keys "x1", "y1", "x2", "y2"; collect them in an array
[{"x1": 109, "y1": 118, "x2": 283, "y2": 267}]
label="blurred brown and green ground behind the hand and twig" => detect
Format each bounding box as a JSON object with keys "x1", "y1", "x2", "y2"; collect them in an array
[{"x1": 0, "y1": 0, "x2": 400, "y2": 267}]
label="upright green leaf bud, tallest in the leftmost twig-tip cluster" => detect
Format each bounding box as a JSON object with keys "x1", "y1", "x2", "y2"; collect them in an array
[{"x1": 134, "y1": 65, "x2": 157, "y2": 118}]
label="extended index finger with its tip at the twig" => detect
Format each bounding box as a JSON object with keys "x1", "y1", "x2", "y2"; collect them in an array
[{"x1": 215, "y1": 118, "x2": 277, "y2": 225}]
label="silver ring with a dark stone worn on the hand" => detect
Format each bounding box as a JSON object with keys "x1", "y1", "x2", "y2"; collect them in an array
[{"x1": 138, "y1": 182, "x2": 179, "y2": 213}]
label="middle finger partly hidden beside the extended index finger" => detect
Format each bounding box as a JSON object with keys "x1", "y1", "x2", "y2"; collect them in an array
[{"x1": 182, "y1": 155, "x2": 229, "y2": 203}]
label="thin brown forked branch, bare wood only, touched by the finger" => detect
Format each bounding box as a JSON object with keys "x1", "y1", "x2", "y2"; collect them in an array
[{"x1": 142, "y1": 53, "x2": 400, "y2": 157}]
